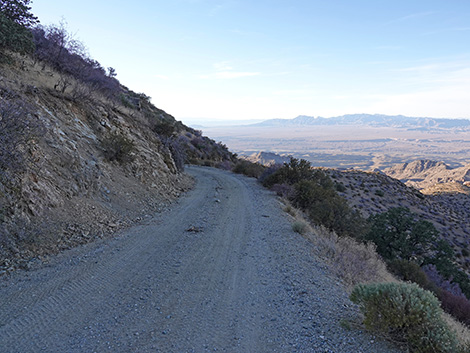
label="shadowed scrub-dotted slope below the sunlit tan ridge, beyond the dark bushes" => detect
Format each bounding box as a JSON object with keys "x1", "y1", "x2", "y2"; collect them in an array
[{"x1": 328, "y1": 169, "x2": 470, "y2": 273}]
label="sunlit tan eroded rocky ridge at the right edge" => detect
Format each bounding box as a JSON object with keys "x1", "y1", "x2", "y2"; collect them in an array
[{"x1": 383, "y1": 160, "x2": 470, "y2": 193}]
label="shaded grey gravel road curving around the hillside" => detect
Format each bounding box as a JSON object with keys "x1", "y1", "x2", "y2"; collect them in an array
[{"x1": 0, "y1": 167, "x2": 400, "y2": 353}]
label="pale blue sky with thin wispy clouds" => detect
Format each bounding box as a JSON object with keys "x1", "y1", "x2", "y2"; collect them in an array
[{"x1": 32, "y1": 0, "x2": 470, "y2": 121}]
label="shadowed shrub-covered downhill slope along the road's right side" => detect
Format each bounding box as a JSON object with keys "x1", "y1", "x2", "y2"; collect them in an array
[{"x1": 237, "y1": 158, "x2": 470, "y2": 352}]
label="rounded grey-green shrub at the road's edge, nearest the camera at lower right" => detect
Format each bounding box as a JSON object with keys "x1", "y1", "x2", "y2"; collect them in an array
[{"x1": 351, "y1": 283, "x2": 458, "y2": 353}]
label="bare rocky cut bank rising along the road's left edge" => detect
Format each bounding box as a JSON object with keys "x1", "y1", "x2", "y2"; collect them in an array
[{"x1": 0, "y1": 51, "x2": 233, "y2": 272}]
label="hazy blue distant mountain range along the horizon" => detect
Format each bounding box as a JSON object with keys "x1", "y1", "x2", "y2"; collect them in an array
[{"x1": 251, "y1": 114, "x2": 470, "y2": 129}]
